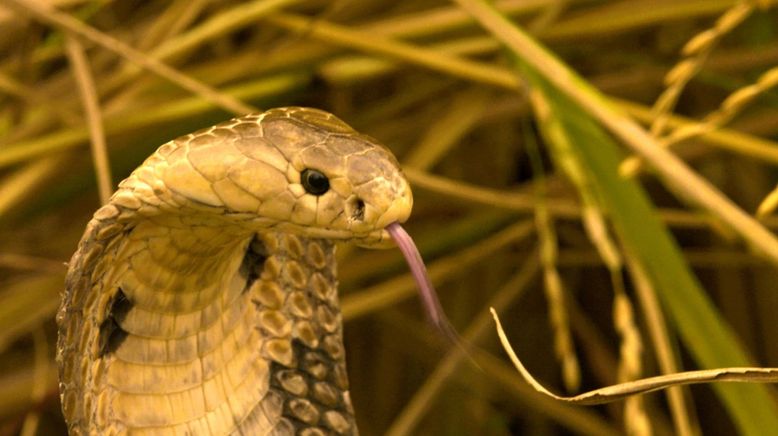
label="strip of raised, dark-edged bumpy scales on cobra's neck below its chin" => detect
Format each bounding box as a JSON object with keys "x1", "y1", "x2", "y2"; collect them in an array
[{"x1": 247, "y1": 232, "x2": 357, "y2": 436}]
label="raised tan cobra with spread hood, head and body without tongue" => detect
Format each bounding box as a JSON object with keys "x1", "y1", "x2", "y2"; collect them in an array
[{"x1": 57, "y1": 107, "x2": 412, "y2": 436}]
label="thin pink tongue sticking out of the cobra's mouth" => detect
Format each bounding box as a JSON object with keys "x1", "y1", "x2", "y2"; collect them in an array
[{"x1": 386, "y1": 222, "x2": 458, "y2": 342}]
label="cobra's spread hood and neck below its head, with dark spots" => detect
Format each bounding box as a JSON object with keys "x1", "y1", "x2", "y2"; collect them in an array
[{"x1": 61, "y1": 209, "x2": 356, "y2": 435}]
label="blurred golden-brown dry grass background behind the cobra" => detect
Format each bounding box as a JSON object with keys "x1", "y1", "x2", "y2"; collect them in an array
[{"x1": 0, "y1": 0, "x2": 778, "y2": 435}]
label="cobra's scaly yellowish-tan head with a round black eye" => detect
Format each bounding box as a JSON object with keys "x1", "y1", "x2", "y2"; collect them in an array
[{"x1": 116, "y1": 107, "x2": 413, "y2": 246}]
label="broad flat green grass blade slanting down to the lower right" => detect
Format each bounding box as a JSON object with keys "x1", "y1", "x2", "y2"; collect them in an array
[{"x1": 521, "y1": 64, "x2": 778, "y2": 436}]
